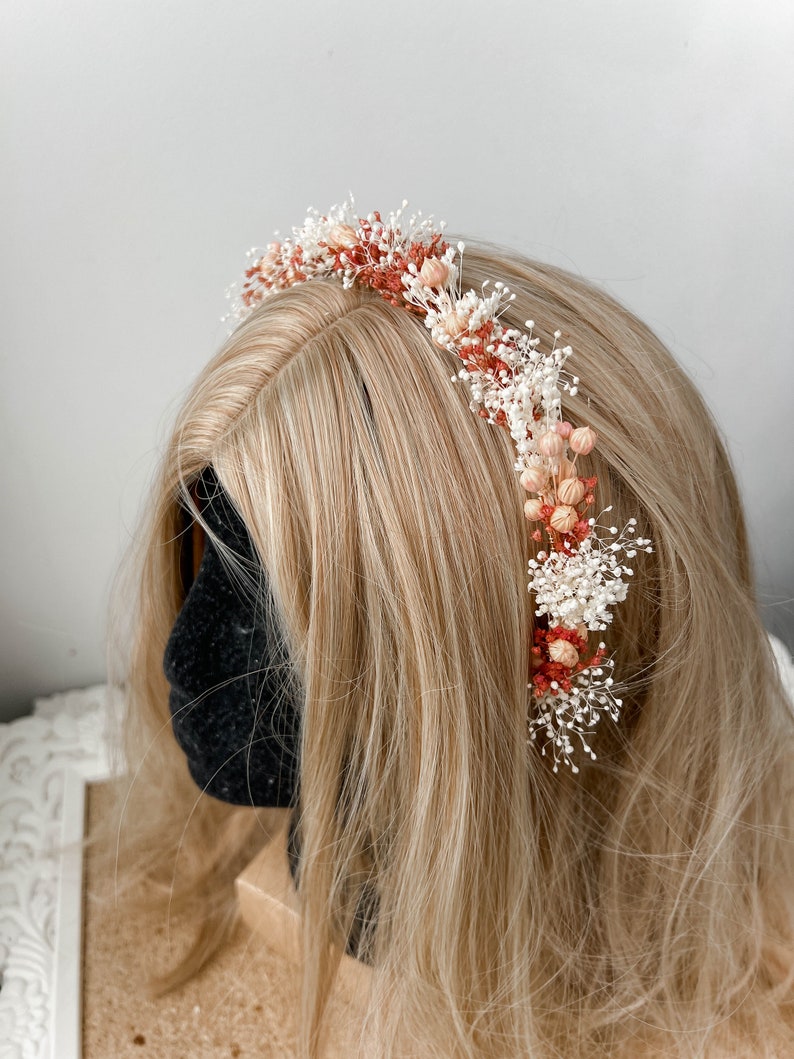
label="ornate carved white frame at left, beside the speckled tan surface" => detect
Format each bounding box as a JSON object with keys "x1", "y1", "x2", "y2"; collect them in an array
[{"x1": 0, "y1": 686, "x2": 110, "y2": 1059}]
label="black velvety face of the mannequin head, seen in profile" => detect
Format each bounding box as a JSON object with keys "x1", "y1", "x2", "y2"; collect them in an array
[{"x1": 164, "y1": 468, "x2": 300, "y2": 807}]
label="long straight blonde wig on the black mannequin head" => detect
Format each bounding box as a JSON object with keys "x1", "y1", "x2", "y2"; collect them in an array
[{"x1": 113, "y1": 246, "x2": 794, "y2": 1059}]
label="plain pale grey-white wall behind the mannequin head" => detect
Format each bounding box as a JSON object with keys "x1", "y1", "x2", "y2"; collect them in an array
[{"x1": 0, "y1": 0, "x2": 794, "y2": 717}]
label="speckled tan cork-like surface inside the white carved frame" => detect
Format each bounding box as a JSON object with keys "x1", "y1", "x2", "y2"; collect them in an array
[{"x1": 83, "y1": 787, "x2": 366, "y2": 1059}]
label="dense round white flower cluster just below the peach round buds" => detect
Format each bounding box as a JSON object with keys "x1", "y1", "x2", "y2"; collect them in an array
[{"x1": 528, "y1": 516, "x2": 651, "y2": 630}]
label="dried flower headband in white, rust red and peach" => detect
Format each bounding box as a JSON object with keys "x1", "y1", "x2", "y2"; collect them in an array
[{"x1": 228, "y1": 201, "x2": 651, "y2": 772}]
